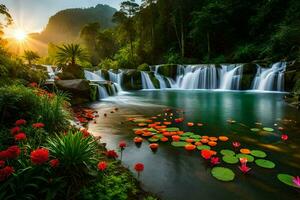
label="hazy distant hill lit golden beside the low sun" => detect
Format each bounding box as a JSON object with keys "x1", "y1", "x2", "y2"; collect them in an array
[{"x1": 30, "y1": 4, "x2": 117, "y2": 53}]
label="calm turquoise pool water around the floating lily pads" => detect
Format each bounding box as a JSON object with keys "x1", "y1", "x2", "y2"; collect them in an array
[{"x1": 90, "y1": 90, "x2": 300, "y2": 200}]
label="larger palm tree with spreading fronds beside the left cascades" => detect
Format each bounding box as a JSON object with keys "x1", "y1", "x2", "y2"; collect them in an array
[{"x1": 56, "y1": 44, "x2": 89, "y2": 66}]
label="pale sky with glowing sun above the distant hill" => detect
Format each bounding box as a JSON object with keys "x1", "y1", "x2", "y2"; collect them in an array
[{"x1": 0, "y1": 0, "x2": 140, "y2": 35}]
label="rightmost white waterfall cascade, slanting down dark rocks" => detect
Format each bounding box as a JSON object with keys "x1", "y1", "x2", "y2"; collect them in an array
[{"x1": 252, "y1": 62, "x2": 286, "y2": 91}]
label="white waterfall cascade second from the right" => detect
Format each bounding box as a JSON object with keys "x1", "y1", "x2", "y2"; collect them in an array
[{"x1": 220, "y1": 65, "x2": 243, "y2": 90}]
